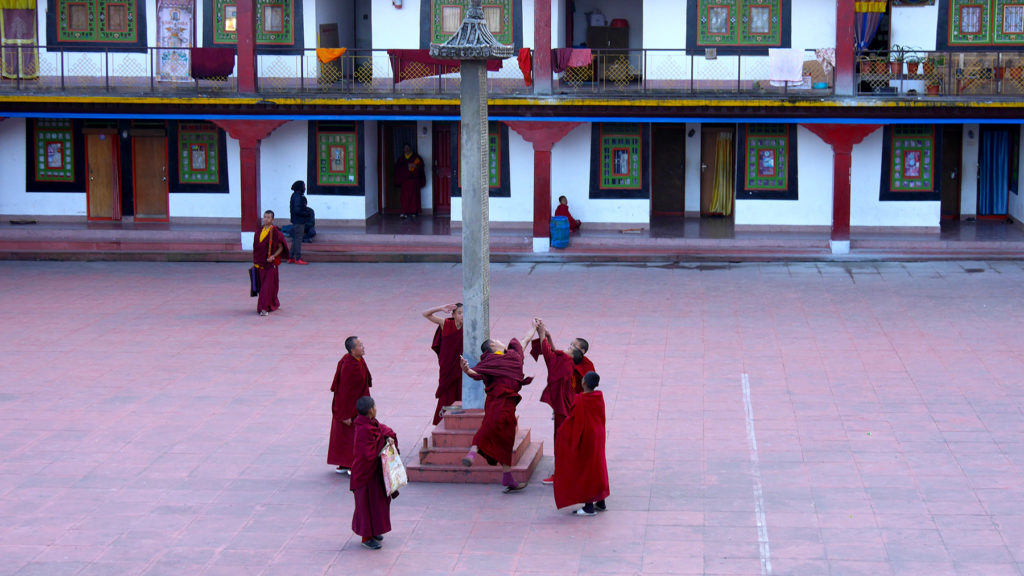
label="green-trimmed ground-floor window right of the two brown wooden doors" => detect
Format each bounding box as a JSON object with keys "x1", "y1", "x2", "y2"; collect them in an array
[{"x1": 167, "y1": 121, "x2": 230, "y2": 194}]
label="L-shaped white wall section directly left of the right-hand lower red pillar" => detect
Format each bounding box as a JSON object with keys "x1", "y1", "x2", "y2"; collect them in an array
[{"x1": 741, "y1": 126, "x2": 833, "y2": 225}]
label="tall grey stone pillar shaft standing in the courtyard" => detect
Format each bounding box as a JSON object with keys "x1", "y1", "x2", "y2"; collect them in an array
[{"x1": 459, "y1": 60, "x2": 490, "y2": 408}]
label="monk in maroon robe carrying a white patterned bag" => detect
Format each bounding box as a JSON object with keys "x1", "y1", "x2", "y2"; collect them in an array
[{"x1": 348, "y1": 396, "x2": 398, "y2": 550}]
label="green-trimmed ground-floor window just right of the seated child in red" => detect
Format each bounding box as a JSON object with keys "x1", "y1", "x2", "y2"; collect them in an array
[{"x1": 590, "y1": 123, "x2": 650, "y2": 199}]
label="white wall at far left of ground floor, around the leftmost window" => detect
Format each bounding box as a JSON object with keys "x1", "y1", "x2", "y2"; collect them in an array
[{"x1": 0, "y1": 118, "x2": 86, "y2": 216}]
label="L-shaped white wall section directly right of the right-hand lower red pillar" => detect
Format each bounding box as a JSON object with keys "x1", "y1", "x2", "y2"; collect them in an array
[{"x1": 850, "y1": 128, "x2": 940, "y2": 228}]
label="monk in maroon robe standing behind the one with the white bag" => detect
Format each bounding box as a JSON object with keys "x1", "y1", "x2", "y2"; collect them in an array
[{"x1": 327, "y1": 336, "x2": 373, "y2": 474}]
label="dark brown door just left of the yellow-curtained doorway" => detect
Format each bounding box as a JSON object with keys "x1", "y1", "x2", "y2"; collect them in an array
[{"x1": 650, "y1": 124, "x2": 686, "y2": 216}]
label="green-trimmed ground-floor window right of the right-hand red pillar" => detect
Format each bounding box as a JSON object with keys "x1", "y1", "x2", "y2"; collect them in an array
[{"x1": 879, "y1": 124, "x2": 941, "y2": 201}]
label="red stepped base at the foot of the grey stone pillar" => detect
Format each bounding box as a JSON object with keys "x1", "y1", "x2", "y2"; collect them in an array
[{"x1": 406, "y1": 410, "x2": 544, "y2": 485}]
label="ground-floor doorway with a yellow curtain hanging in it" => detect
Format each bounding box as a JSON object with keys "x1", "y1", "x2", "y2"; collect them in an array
[{"x1": 700, "y1": 126, "x2": 736, "y2": 216}]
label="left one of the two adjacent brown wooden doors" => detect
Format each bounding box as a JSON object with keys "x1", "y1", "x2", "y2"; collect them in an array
[{"x1": 85, "y1": 130, "x2": 121, "y2": 220}]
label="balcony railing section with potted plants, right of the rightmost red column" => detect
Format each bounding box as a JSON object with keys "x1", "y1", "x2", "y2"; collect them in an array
[{"x1": 857, "y1": 50, "x2": 1024, "y2": 97}]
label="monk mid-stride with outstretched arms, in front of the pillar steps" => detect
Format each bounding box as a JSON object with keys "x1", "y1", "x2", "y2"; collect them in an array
[{"x1": 460, "y1": 321, "x2": 537, "y2": 487}]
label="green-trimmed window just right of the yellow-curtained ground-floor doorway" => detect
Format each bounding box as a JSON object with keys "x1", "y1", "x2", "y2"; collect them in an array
[{"x1": 736, "y1": 124, "x2": 799, "y2": 200}]
